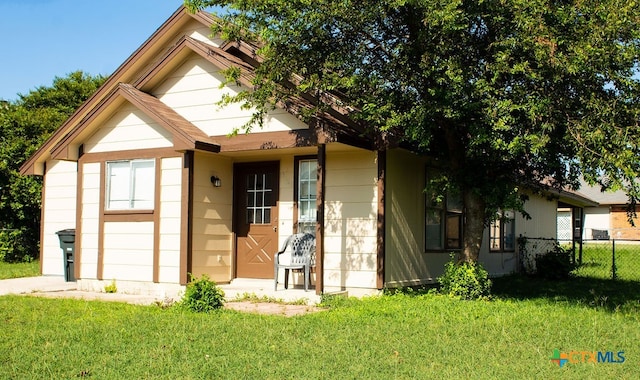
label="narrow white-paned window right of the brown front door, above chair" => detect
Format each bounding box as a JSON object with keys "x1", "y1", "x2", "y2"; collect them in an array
[{"x1": 297, "y1": 159, "x2": 318, "y2": 234}]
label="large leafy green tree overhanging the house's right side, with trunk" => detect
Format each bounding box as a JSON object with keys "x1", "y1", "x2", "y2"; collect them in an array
[{"x1": 185, "y1": 0, "x2": 640, "y2": 261}]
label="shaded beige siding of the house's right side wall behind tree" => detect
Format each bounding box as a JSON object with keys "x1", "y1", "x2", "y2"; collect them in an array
[{"x1": 385, "y1": 149, "x2": 557, "y2": 286}]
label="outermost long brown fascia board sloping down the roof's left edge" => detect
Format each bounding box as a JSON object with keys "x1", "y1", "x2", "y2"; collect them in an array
[{"x1": 20, "y1": 5, "x2": 214, "y2": 175}]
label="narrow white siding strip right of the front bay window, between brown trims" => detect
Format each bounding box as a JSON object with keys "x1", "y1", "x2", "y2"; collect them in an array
[{"x1": 158, "y1": 157, "x2": 182, "y2": 283}]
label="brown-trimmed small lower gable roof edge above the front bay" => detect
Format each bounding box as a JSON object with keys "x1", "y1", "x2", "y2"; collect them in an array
[{"x1": 51, "y1": 83, "x2": 220, "y2": 160}]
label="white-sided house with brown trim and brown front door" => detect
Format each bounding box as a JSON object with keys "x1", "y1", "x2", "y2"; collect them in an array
[{"x1": 22, "y1": 7, "x2": 583, "y2": 295}]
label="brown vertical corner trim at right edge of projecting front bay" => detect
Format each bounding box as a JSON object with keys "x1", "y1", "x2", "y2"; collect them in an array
[{"x1": 180, "y1": 151, "x2": 194, "y2": 285}]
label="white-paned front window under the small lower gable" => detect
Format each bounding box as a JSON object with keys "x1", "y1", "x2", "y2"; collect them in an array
[{"x1": 106, "y1": 160, "x2": 155, "y2": 210}]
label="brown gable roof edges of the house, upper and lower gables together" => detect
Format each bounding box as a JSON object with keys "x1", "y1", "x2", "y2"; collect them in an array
[{"x1": 20, "y1": 6, "x2": 373, "y2": 175}]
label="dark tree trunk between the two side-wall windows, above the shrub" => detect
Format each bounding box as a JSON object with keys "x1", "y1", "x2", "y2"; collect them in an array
[{"x1": 460, "y1": 189, "x2": 485, "y2": 262}]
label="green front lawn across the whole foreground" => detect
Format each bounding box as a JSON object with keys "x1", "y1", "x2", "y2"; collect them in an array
[{"x1": 0, "y1": 276, "x2": 640, "y2": 379}]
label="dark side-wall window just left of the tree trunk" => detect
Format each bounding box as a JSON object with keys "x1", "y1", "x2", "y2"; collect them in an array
[{"x1": 425, "y1": 168, "x2": 462, "y2": 251}]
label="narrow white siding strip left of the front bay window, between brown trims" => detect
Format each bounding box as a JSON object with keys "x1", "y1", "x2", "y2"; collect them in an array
[{"x1": 76, "y1": 163, "x2": 102, "y2": 279}]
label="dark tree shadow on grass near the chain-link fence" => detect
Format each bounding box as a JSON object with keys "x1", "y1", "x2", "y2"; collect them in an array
[{"x1": 491, "y1": 275, "x2": 640, "y2": 312}]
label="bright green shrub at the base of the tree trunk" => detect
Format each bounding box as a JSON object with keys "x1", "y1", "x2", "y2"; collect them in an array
[{"x1": 438, "y1": 255, "x2": 491, "y2": 300}]
